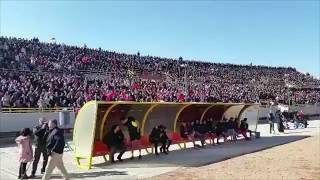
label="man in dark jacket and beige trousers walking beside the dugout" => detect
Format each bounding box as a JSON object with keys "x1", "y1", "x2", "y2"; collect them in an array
[{"x1": 42, "y1": 119, "x2": 69, "y2": 180}]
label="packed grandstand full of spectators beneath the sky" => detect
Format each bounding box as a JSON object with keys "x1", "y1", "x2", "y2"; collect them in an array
[{"x1": 0, "y1": 37, "x2": 320, "y2": 108}]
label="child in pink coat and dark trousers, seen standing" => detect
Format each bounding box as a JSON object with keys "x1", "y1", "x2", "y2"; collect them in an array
[{"x1": 16, "y1": 128, "x2": 33, "y2": 179}]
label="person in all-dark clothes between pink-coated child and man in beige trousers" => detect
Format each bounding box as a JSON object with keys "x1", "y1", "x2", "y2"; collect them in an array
[{"x1": 30, "y1": 118, "x2": 49, "y2": 178}]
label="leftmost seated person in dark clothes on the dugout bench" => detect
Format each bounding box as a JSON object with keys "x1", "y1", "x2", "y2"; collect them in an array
[{"x1": 103, "y1": 125, "x2": 126, "y2": 163}]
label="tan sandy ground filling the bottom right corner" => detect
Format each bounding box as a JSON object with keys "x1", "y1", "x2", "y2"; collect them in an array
[{"x1": 150, "y1": 133, "x2": 320, "y2": 180}]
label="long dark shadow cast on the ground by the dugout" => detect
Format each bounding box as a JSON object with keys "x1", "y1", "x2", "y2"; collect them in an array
[{"x1": 94, "y1": 135, "x2": 310, "y2": 169}]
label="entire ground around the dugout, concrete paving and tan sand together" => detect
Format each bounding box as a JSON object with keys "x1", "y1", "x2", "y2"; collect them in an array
[{"x1": 0, "y1": 120, "x2": 320, "y2": 180}]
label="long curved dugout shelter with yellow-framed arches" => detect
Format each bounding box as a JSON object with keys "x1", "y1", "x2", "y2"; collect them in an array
[{"x1": 73, "y1": 101, "x2": 260, "y2": 169}]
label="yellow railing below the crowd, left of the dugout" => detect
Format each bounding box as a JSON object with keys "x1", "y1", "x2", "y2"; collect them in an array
[{"x1": 0, "y1": 107, "x2": 76, "y2": 113}]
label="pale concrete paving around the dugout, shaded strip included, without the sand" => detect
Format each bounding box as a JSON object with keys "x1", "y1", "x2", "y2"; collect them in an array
[{"x1": 0, "y1": 120, "x2": 320, "y2": 180}]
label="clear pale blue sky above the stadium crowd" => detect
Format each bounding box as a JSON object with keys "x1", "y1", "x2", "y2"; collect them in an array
[{"x1": 0, "y1": 0, "x2": 320, "y2": 77}]
